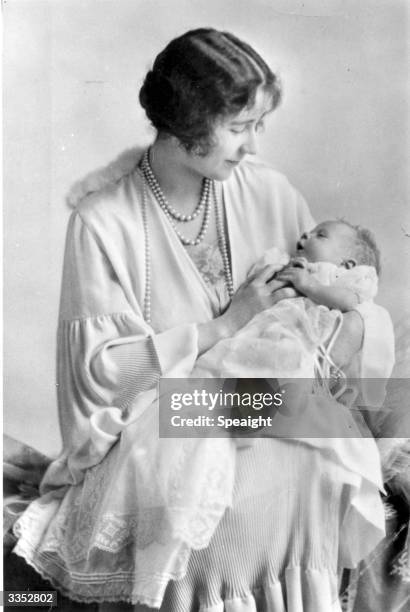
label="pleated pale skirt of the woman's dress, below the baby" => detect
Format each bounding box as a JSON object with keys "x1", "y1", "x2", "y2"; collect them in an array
[{"x1": 154, "y1": 440, "x2": 383, "y2": 612}]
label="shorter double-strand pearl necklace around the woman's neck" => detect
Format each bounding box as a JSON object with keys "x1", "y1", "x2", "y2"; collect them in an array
[{"x1": 141, "y1": 150, "x2": 212, "y2": 246}]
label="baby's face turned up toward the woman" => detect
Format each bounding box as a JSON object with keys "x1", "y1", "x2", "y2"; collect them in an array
[{"x1": 296, "y1": 221, "x2": 355, "y2": 266}]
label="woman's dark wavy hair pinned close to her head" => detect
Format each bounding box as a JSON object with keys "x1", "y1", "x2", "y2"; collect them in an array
[{"x1": 139, "y1": 28, "x2": 281, "y2": 155}]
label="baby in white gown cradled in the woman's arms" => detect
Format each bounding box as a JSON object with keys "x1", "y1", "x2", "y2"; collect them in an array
[{"x1": 193, "y1": 220, "x2": 393, "y2": 406}]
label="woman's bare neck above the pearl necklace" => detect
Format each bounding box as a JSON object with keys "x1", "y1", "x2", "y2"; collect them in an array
[{"x1": 150, "y1": 137, "x2": 203, "y2": 213}]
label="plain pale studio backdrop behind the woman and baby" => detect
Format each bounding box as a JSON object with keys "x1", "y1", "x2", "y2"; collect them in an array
[{"x1": 3, "y1": 0, "x2": 410, "y2": 454}]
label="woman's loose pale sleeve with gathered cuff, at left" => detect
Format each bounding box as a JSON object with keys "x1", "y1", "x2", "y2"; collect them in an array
[{"x1": 46, "y1": 211, "x2": 198, "y2": 486}]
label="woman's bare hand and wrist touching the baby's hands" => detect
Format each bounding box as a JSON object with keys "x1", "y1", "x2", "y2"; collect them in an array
[{"x1": 198, "y1": 265, "x2": 298, "y2": 354}]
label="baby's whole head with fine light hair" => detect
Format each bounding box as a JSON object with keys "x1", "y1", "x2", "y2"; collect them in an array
[{"x1": 296, "y1": 220, "x2": 380, "y2": 274}]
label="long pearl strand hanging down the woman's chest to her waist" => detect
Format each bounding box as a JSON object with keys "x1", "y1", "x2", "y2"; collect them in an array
[{"x1": 140, "y1": 154, "x2": 234, "y2": 324}]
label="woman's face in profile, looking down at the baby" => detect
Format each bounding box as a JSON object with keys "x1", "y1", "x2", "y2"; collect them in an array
[{"x1": 186, "y1": 87, "x2": 271, "y2": 181}]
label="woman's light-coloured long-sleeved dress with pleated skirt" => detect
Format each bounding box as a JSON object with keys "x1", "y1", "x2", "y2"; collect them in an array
[{"x1": 15, "y1": 153, "x2": 385, "y2": 612}]
